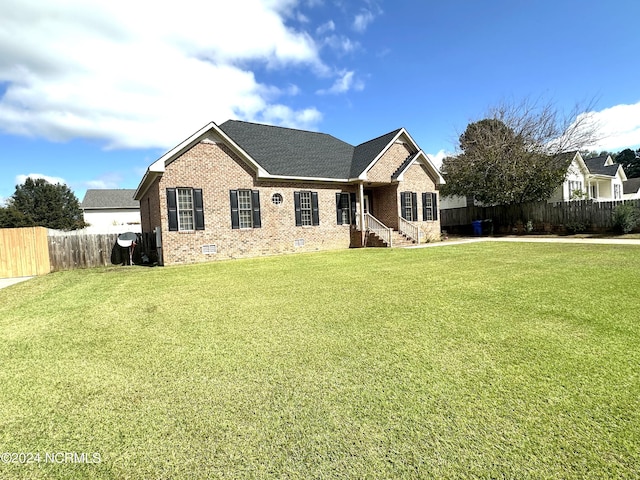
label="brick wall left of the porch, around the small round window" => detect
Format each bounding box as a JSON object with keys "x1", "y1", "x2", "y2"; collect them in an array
[{"x1": 141, "y1": 143, "x2": 356, "y2": 265}]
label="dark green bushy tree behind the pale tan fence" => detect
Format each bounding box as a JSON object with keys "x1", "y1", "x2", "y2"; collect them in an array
[{"x1": 0, "y1": 178, "x2": 86, "y2": 230}]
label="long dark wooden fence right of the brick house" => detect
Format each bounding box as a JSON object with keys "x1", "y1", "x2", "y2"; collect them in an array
[{"x1": 440, "y1": 200, "x2": 640, "y2": 233}]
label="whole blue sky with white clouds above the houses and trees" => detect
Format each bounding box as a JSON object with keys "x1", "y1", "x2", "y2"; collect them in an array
[{"x1": 0, "y1": 0, "x2": 640, "y2": 201}]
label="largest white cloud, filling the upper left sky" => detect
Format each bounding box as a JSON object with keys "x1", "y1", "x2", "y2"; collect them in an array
[{"x1": 0, "y1": 0, "x2": 330, "y2": 148}]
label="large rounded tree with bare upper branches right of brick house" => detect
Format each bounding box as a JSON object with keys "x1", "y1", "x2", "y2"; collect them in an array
[{"x1": 441, "y1": 98, "x2": 597, "y2": 205}]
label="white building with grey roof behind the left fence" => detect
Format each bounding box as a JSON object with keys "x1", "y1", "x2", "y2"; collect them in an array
[{"x1": 80, "y1": 189, "x2": 142, "y2": 233}]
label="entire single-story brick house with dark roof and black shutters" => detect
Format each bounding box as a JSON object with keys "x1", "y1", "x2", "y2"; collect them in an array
[{"x1": 134, "y1": 120, "x2": 444, "y2": 265}]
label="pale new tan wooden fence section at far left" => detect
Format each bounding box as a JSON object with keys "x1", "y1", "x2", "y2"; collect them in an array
[{"x1": 0, "y1": 227, "x2": 51, "y2": 278}]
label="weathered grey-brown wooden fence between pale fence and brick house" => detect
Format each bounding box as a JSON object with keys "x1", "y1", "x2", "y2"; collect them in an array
[{"x1": 49, "y1": 230, "x2": 118, "y2": 271}]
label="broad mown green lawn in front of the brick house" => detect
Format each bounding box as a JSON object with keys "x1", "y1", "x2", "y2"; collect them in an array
[{"x1": 0, "y1": 243, "x2": 640, "y2": 479}]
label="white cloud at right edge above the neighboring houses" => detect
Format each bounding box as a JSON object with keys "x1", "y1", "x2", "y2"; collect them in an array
[{"x1": 586, "y1": 102, "x2": 640, "y2": 152}]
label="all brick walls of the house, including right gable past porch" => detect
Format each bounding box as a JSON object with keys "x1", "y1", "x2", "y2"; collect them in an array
[{"x1": 140, "y1": 134, "x2": 440, "y2": 265}]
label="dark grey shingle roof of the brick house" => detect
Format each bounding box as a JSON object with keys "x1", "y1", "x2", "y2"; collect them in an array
[{"x1": 220, "y1": 120, "x2": 400, "y2": 179}]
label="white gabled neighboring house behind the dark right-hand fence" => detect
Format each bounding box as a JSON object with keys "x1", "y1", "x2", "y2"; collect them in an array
[{"x1": 548, "y1": 152, "x2": 627, "y2": 203}]
